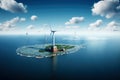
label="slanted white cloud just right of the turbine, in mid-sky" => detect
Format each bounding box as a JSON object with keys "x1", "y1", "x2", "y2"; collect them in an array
[{"x1": 65, "y1": 17, "x2": 84, "y2": 25}]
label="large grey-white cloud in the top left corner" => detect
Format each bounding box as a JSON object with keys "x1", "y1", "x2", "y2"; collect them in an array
[{"x1": 0, "y1": 0, "x2": 27, "y2": 13}]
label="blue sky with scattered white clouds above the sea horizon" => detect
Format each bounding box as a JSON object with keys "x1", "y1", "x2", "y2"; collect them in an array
[{"x1": 0, "y1": 0, "x2": 120, "y2": 34}]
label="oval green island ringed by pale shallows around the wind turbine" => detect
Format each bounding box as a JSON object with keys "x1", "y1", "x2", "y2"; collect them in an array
[{"x1": 16, "y1": 44, "x2": 80, "y2": 58}]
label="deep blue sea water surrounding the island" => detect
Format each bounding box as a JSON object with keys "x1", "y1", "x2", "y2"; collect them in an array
[{"x1": 0, "y1": 35, "x2": 120, "y2": 80}]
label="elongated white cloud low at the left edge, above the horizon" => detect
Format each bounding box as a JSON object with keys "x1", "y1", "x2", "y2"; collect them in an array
[{"x1": 0, "y1": 17, "x2": 24, "y2": 31}]
